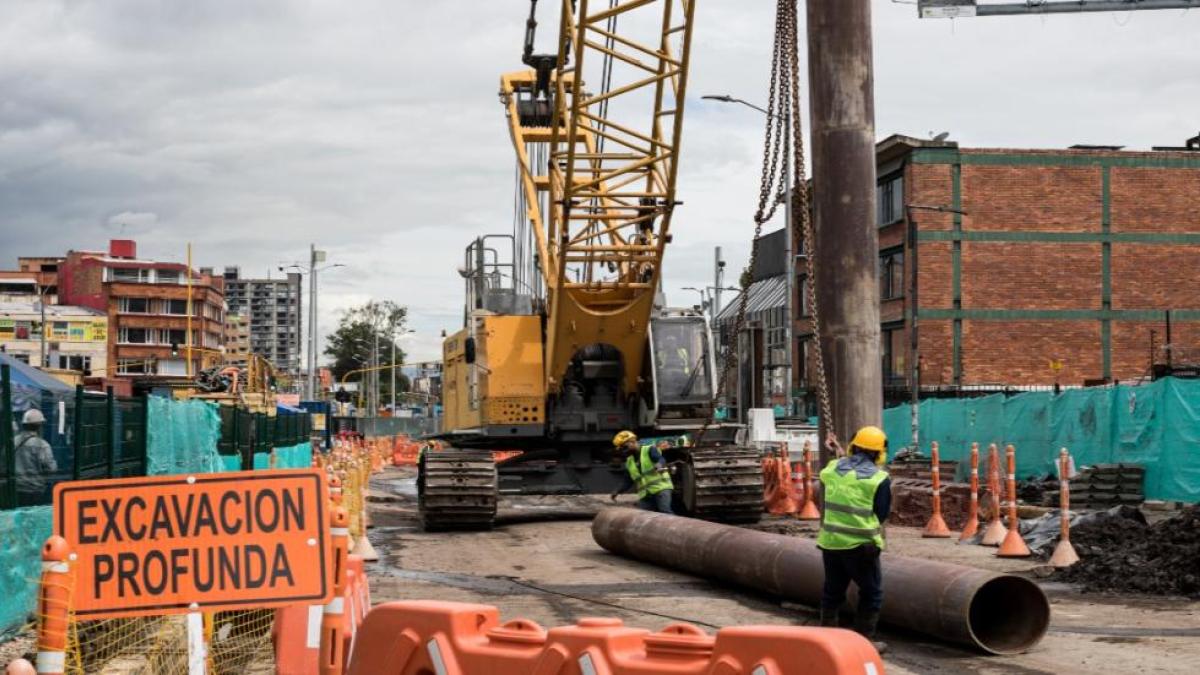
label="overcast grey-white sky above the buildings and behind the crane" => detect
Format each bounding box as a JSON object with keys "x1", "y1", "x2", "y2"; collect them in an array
[{"x1": 0, "y1": 0, "x2": 1200, "y2": 358}]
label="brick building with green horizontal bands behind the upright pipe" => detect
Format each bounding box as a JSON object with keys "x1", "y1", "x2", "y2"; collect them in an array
[{"x1": 796, "y1": 136, "x2": 1200, "y2": 394}]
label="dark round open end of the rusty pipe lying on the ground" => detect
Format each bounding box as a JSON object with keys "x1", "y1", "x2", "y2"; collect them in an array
[{"x1": 968, "y1": 577, "x2": 1050, "y2": 655}]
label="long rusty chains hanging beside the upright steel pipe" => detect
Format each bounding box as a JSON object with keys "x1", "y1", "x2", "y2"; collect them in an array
[{"x1": 696, "y1": 0, "x2": 833, "y2": 444}]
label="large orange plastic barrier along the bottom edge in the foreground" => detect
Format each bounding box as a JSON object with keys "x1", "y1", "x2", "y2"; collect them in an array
[{"x1": 347, "y1": 601, "x2": 883, "y2": 675}]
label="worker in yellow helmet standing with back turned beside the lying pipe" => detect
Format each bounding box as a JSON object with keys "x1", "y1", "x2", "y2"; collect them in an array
[{"x1": 817, "y1": 426, "x2": 892, "y2": 651}]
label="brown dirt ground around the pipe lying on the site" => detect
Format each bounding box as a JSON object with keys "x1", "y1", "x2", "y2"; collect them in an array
[{"x1": 368, "y1": 470, "x2": 1200, "y2": 674}]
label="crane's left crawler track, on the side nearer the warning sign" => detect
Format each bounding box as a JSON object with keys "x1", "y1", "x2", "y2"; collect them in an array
[{"x1": 416, "y1": 448, "x2": 498, "y2": 532}]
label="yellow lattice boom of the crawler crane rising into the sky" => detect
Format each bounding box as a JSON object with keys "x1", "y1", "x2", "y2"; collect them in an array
[{"x1": 500, "y1": 0, "x2": 695, "y2": 394}]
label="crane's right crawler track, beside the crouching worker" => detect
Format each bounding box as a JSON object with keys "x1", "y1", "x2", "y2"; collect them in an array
[{"x1": 679, "y1": 446, "x2": 763, "y2": 524}]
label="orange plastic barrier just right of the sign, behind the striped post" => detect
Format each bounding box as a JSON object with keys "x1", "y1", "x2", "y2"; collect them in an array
[{"x1": 272, "y1": 555, "x2": 371, "y2": 675}]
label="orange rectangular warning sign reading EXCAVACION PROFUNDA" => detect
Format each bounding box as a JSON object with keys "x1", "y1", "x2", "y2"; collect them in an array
[{"x1": 54, "y1": 468, "x2": 334, "y2": 619}]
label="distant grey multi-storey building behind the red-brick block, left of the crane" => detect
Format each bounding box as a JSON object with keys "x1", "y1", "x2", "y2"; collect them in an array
[{"x1": 224, "y1": 267, "x2": 301, "y2": 376}]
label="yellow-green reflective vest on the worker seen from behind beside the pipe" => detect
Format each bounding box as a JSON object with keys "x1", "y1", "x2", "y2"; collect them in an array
[{"x1": 817, "y1": 459, "x2": 888, "y2": 550}]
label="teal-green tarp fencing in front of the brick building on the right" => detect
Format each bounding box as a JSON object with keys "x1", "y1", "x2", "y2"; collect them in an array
[{"x1": 883, "y1": 377, "x2": 1200, "y2": 502}]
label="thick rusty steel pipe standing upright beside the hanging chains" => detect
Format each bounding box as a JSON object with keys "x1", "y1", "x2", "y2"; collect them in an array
[{"x1": 808, "y1": 0, "x2": 883, "y2": 466}]
